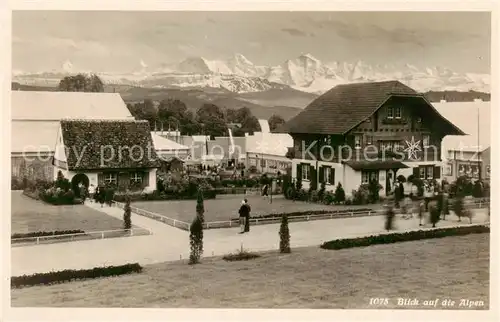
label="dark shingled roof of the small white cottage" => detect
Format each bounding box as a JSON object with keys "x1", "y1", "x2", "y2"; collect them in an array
[{"x1": 61, "y1": 120, "x2": 159, "y2": 170}]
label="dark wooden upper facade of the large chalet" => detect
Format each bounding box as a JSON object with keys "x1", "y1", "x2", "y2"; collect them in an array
[{"x1": 291, "y1": 97, "x2": 446, "y2": 163}]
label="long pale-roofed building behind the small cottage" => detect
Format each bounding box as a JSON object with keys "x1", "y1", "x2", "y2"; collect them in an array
[{"x1": 11, "y1": 91, "x2": 134, "y2": 180}]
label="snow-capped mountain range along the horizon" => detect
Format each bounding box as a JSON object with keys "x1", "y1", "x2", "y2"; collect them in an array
[{"x1": 13, "y1": 54, "x2": 490, "y2": 94}]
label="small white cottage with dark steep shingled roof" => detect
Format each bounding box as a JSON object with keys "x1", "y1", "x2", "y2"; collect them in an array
[{"x1": 53, "y1": 120, "x2": 160, "y2": 191}]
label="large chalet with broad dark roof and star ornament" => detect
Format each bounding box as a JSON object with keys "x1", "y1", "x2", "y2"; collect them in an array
[{"x1": 280, "y1": 81, "x2": 464, "y2": 195}]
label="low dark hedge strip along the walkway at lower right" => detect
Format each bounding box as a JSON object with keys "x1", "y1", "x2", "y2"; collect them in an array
[{"x1": 320, "y1": 226, "x2": 490, "y2": 249}]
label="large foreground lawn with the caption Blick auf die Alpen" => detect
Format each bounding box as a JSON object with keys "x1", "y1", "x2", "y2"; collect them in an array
[{"x1": 11, "y1": 234, "x2": 490, "y2": 309}]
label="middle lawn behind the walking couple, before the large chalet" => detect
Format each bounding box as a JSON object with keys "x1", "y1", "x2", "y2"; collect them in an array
[{"x1": 132, "y1": 195, "x2": 376, "y2": 223}]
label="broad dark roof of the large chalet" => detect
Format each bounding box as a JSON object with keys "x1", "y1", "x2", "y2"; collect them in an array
[{"x1": 280, "y1": 81, "x2": 419, "y2": 134}]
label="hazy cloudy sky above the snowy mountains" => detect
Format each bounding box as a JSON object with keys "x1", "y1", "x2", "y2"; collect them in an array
[{"x1": 12, "y1": 11, "x2": 491, "y2": 73}]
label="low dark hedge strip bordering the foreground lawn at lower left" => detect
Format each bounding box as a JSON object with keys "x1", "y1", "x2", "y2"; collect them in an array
[{"x1": 10, "y1": 263, "x2": 142, "y2": 288}]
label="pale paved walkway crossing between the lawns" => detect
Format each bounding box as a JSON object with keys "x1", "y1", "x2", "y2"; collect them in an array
[{"x1": 11, "y1": 204, "x2": 488, "y2": 276}]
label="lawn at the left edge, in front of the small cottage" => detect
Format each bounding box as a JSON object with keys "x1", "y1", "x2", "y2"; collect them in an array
[{"x1": 11, "y1": 191, "x2": 128, "y2": 234}]
